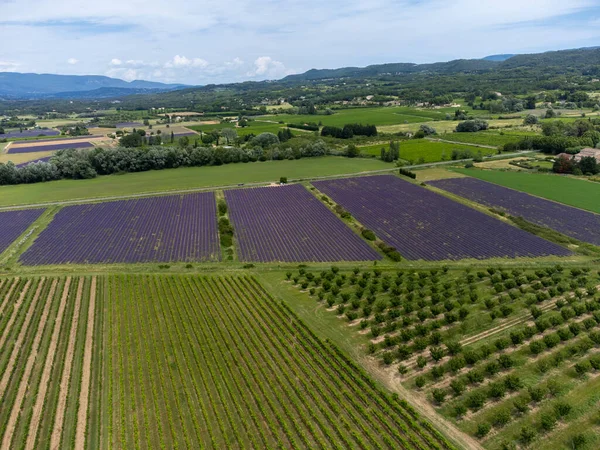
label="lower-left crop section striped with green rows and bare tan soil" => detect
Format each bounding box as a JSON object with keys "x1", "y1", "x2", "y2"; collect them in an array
[{"x1": 0, "y1": 277, "x2": 100, "y2": 449}]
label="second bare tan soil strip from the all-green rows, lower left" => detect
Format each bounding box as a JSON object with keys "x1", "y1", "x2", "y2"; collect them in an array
[{"x1": 50, "y1": 278, "x2": 83, "y2": 450}]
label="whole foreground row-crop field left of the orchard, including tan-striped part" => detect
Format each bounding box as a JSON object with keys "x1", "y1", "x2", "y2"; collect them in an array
[{"x1": 0, "y1": 275, "x2": 453, "y2": 449}]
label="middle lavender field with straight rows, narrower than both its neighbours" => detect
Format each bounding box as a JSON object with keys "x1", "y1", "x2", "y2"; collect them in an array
[{"x1": 225, "y1": 184, "x2": 381, "y2": 262}]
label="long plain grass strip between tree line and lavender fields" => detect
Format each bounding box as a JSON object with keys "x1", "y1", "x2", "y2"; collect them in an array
[{"x1": 0, "y1": 156, "x2": 393, "y2": 206}]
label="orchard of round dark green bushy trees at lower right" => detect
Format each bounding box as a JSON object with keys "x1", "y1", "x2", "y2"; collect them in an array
[{"x1": 284, "y1": 266, "x2": 600, "y2": 449}]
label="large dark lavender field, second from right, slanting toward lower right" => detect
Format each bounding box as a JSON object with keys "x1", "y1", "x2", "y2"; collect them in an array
[{"x1": 313, "y1": 175, "x2": 571, "y2": 261}]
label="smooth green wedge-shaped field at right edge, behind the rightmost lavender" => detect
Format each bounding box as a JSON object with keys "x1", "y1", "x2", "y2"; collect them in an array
[{"x1": 456, "y1": 169, "x2": 600, "y2": 214}]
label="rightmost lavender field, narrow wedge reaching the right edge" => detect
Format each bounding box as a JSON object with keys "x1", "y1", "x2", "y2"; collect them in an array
[{"x1": 429, "y1": 178, "x2": 600, "y2": 245}]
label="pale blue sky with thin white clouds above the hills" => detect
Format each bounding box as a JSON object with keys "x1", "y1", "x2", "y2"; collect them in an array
[{"x1": 0, "y1": 0, "x2": 600, "y2": 85}]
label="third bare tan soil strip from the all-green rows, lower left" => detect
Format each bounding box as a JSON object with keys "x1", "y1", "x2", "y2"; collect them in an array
[{"x1": 25, "y1": 277, "x2": 71, "y2": 450}]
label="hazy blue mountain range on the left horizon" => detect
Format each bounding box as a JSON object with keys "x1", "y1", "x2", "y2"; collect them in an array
[{"x1": 0, "y1": 72, "x2": 188, "y2": 98}]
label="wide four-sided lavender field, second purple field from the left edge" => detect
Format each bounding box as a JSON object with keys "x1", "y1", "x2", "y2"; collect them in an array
[{"x1": 21, "y1": 192, "x2": 221, "y2": 265}]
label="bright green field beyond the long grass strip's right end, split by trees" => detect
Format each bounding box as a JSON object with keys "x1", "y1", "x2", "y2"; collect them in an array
[{"x1": 359, "y1": 139, "x2": 495, "y2": 164}]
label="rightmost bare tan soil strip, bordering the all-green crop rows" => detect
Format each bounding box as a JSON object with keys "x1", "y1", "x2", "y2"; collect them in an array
[{"x1": 75, "y1": 277, "x2": 96, "y2": 448}]
